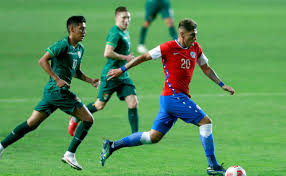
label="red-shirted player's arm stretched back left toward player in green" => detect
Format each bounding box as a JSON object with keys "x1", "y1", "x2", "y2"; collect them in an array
[{"x1": 106, "y1": 53, "x2": 152, "y2": 80}]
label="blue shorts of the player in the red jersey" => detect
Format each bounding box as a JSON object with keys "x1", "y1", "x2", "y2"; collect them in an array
[{"x1": 152, "y1": 93, "x2": 206, "y2": 134}]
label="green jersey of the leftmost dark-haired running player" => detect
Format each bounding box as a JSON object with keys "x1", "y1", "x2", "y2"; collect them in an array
[{"x1": 45, "y1": 37, "x2": 84, "y2": 89}]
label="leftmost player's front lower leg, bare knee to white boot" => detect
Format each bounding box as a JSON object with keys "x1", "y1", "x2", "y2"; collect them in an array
[{"x1": 62, "y1": 106, "x2": 93, "y2": 170}]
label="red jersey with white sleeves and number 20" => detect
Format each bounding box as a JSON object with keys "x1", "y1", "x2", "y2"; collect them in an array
[{"x1": 149, "y1": 40, "x2": 208, "y2": 97}]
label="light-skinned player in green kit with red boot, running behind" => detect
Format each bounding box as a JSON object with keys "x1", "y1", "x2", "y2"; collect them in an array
[{"x1": 68, "y1": 7, "x2": 138, "y2": 136}]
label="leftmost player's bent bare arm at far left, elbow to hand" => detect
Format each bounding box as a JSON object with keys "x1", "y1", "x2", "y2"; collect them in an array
[{"x1": 39, "y1": 52, "x2": 70, "y2": 88}]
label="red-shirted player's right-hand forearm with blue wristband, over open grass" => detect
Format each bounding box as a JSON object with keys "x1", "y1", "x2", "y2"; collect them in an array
[{"x1": 201, "y1": 64, "x2": 235, "y2": 95}]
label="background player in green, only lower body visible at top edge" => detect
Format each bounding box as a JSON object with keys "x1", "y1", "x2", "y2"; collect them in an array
[{"x1": 137, "y1": 0, "x2": 177, "y2": 54}]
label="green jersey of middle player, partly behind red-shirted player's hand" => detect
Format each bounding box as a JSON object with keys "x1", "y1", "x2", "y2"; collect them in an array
[{"x1": 101, "y1": 25, "x2": 130, "y2": 79}]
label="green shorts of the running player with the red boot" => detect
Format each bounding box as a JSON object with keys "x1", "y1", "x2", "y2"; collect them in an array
[{"x1": 97, "y1": 78, "x2": 136, "y2": 102}]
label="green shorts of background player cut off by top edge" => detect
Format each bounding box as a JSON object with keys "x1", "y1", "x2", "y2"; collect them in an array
[{"x1": 145, "y1": 2, "x2": 173, "y2": 22}]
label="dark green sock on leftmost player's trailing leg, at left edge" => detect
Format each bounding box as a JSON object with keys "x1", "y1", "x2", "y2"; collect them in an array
[{"x1": 1, "y1": 121, "x2": 33, "y2": 148}]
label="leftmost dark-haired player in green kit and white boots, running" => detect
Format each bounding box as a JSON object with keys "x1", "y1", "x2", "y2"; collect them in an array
[{"x1": 0, "y1": 16, "x2": 99, "y2": 170}]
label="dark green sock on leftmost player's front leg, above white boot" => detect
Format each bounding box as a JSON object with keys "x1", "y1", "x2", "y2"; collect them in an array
[{"x1": 68, "y1": 121, "x2": 93, "y2": 153}]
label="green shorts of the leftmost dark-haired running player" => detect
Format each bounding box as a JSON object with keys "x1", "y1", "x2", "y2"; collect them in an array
[{"x1": 35, "y1": 89, "x2": 83, "y2": 116}]
